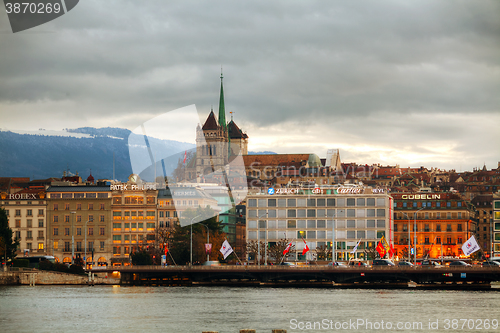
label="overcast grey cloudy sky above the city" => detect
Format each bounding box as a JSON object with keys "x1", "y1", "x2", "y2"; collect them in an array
[{"x1": 0, "y1": 0, "x2": 500, "y2": 171}]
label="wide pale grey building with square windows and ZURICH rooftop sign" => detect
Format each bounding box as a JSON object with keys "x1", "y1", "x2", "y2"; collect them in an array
[{"x1": 246, "y1": 186, "x2": 392, "y2": 261}]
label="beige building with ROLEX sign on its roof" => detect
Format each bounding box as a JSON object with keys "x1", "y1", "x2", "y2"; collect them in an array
[{"x1": 0, "y1": 187, "x2": 49, "y2": 256}]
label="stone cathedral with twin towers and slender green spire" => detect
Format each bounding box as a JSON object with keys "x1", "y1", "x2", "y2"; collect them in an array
[{"x1": 185, "y1": 73, "x2": 248, "y2": 181}]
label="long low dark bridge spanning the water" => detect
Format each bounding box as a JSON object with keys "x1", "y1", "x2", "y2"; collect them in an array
[{"x1": 92, "y1": 265, "x2": 500, "y2": 289}]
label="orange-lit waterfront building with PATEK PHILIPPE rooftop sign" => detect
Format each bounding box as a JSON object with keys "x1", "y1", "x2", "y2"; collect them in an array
[{"x1": 110, "y1": 174, "x2": 158, "y2": 265}]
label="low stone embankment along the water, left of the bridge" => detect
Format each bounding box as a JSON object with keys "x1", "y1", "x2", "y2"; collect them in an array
[{"x1": 0, "y1": 269, "x2": 120, "y2": 286}]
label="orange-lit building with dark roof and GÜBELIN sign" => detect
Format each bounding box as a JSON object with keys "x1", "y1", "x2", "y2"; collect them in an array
[{"x1": 391, "y1": 192, "x2": 477, "y2": 259}]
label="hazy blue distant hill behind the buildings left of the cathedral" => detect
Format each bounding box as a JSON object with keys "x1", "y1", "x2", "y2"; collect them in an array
[{"x1": 0, "y1": 127, "x2": 194, "y2": 181}]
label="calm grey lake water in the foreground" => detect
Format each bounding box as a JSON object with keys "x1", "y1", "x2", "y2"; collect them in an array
[{"x1": 0, "y1": 286, "x2": 500, "y2": 333}]
